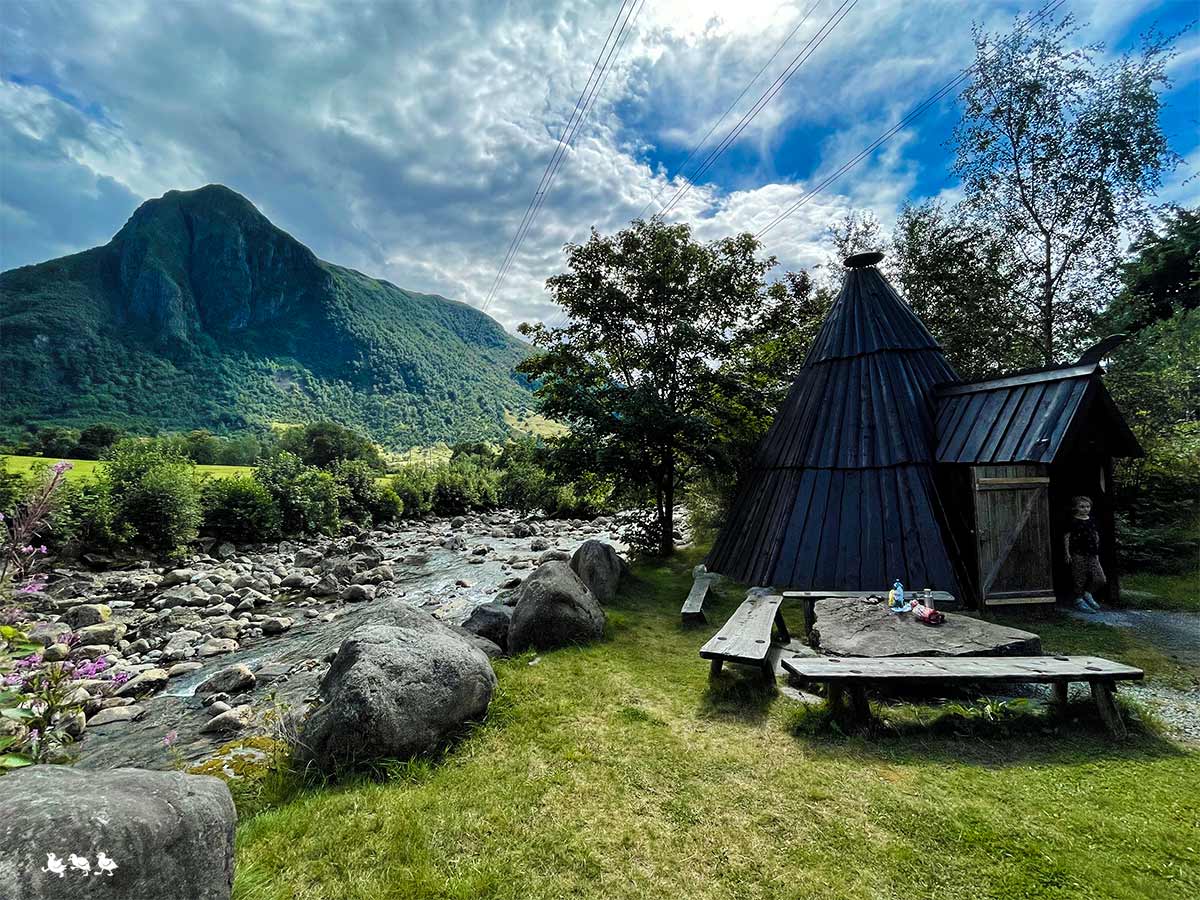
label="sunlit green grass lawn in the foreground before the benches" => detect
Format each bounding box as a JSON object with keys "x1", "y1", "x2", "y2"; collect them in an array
[{"x1": 234, "y1": 554, "x2": 1200, "y2": 900}]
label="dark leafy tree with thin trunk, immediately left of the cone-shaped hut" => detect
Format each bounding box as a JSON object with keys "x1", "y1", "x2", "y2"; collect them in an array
[{"x1": 518, "y1": 220, "x2": 774, "y2": 556}]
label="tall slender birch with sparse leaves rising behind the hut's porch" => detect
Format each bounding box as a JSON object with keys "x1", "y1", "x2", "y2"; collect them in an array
[{"x1": 954, "y1": 17, "x2": 1177, "y2": 365}]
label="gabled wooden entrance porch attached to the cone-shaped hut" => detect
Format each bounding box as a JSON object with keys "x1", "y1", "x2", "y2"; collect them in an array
[{"x1": 935, "y1": 362, "x2": 1141, "y2": 606}]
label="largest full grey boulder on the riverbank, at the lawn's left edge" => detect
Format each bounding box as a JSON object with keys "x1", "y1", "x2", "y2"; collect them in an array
[{"x1": 298, "y1": 619, "x2": 496, "y2": 772}]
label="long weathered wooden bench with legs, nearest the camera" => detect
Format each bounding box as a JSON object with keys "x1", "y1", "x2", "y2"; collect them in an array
[{"x1": 782, "y1": 656, "x2": 1145, "y2": 737}]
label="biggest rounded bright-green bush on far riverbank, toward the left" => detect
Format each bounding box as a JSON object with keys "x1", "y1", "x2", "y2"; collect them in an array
[{"x1": 103, "y1": 438, "x2": 200, "y2": 553}]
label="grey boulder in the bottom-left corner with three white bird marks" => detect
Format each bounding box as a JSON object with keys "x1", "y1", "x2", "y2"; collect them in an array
[{"x1": 0, "y1": 766, "x2": 238, "y2": 900}]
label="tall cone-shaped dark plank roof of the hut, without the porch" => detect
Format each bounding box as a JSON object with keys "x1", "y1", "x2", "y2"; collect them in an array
[{"x1": 708, "y1": 260, "x2": 958, "y2": 593}]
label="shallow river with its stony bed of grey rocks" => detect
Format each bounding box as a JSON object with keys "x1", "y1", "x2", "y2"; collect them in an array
[{"x1": 9, "y1": 512, "x2": 622, "y2": 768}]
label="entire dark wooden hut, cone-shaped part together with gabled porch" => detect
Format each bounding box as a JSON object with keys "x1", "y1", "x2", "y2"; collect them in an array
[{"x1": 708, "y1": 253, "x2": 1141, "y2": 607}]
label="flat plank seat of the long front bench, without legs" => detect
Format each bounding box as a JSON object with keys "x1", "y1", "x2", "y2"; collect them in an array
[{"x1": 781, "y1": 656, "x2": 1144, "y2": 683}]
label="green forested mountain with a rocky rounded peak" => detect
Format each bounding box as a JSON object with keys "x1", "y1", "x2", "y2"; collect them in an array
[{"x1": 0, "y1": 185, "x2": 529, "y2": 446}]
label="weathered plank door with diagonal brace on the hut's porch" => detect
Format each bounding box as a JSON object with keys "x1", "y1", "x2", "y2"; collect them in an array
[{"x1": 972, "y1": 464, "x2": 1055, "y2": 606}]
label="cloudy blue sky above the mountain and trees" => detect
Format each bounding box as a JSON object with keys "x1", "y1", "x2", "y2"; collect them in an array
[{"x1": 0, "y1": 0, "x2": 1200, "y2": 329}]
